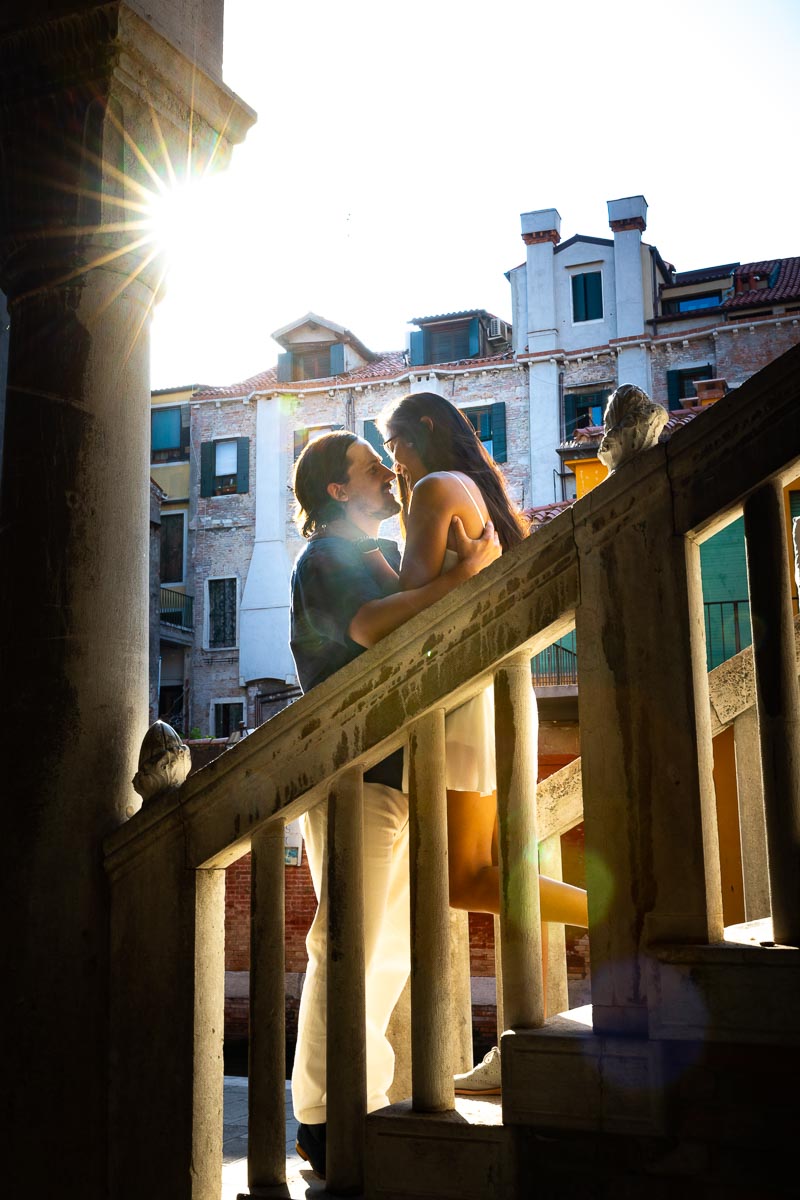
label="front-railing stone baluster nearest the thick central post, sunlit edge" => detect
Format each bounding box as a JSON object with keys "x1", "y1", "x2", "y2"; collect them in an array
[{"x1": 494, "y1": 654, "x2": 545, "y2": 1030}]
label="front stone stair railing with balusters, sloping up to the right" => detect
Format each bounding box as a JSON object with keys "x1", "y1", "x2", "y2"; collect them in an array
[{"x1": 107, "y1": 350, "x2": 800, "y2": 1200}]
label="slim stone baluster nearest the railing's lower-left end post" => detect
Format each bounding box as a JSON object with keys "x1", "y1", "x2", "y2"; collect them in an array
[{"x1": 247, "y1": 822, "x2": 287, "y2": 1192}]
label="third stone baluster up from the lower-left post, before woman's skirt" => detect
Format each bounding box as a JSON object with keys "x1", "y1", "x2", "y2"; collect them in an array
[{"x1": 409, "y1": 709, "x2": 455, "y2": 1112}]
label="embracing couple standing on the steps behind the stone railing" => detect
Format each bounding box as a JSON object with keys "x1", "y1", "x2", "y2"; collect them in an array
[{"x1": 291, "y1": 392, "x2": 587, "y2": 1176}]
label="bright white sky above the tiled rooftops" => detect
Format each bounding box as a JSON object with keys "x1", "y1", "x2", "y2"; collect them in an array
[{"x1": 152, "y1": 0, "x2": 800, "y2": 388}]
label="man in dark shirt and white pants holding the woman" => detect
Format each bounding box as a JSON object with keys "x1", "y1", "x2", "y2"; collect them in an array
[{"x1": 291, "y1": 431, "x2": 500, "y2": 1176}]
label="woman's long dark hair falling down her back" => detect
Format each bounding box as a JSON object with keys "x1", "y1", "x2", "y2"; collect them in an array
[{"x1": 378, "y1": 391, "x2": 529, "y2": 550}]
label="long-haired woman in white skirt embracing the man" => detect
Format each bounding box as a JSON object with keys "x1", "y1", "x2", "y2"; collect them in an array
[{"x1": 379, "y1": 391, "x2": 588, "y2": 926}]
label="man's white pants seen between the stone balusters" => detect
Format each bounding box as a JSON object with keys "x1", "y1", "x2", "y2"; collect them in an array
[{"x1": 291, "y1": 784, "x2": 410, "y2": 1124}]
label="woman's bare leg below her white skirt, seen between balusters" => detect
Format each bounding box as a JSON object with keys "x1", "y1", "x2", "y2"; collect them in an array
[{"x1": 447, "y1": 792, "x2": 589, "y2": 929}]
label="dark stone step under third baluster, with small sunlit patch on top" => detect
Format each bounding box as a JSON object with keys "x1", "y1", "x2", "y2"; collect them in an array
[{"x1": 365, "y1": 1097, "x2": 512, "y2": 1200}]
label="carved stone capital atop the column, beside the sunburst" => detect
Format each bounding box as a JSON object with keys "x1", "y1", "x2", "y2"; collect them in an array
[{"x1": 0, "y1": 4, "x2": 255, "y2": 305}]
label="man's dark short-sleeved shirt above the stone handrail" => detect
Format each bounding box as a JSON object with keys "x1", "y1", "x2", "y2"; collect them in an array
[{"x1": 291, "y1": 538, "x2": 403, "y2": 788}]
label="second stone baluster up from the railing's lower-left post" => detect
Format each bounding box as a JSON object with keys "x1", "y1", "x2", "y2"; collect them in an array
[{"x1": 326, "y1": 767, "x2": 367, "y2": 1195}]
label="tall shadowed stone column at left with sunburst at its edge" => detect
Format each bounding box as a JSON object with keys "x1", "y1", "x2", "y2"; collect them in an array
[{"x1": 0, "y1": 0, "x2": 252, "y2": 1200}]
